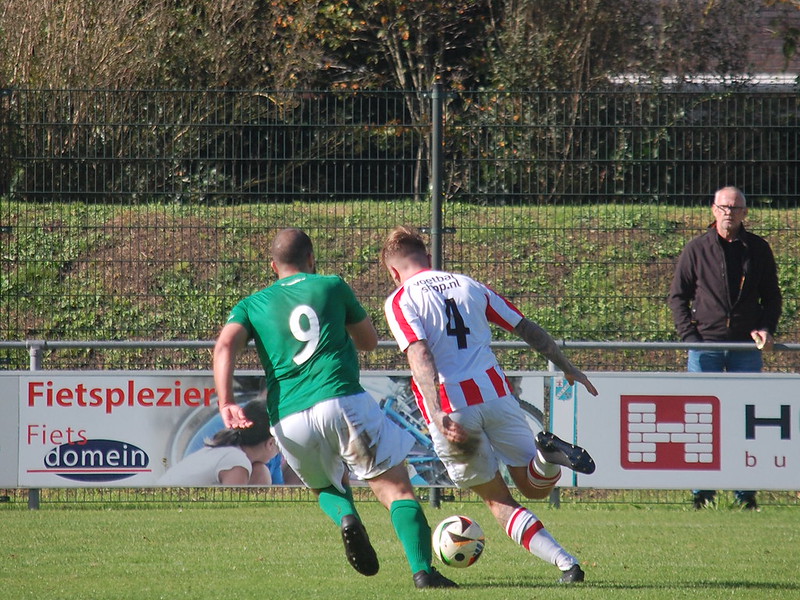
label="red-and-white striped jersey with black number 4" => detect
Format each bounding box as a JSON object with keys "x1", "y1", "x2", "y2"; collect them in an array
[{"x1": 384, "y1": 269, "x2": 522, "y2": 419}]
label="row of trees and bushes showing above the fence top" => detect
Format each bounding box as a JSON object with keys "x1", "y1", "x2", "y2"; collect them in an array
[{"x1": 0, "y1": 0, "x2": 788, "y2": 91}]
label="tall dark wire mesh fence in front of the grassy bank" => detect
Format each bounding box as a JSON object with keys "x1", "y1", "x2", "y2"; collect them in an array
[{"x1": 0, "y1": 89, "x2": 800, "y2": 371}]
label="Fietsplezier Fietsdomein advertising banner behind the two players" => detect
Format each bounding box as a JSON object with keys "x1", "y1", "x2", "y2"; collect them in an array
[{"x1": 0, "y1": 371, "x2": 545, "y2": 488}]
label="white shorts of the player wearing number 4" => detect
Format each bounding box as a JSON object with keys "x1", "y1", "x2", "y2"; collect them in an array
[{"x1": 430, "y1": 395, "x2": 536, "y2": 488}]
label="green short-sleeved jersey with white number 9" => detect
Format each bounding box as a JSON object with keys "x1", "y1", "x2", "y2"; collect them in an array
[{"x1": 228, "y1": 273, "x2": 367, "y2": 425}]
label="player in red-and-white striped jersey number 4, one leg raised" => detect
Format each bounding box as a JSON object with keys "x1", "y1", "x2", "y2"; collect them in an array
[{"x1": 381, "y1": 227, "x2": 597, "y2": 583}]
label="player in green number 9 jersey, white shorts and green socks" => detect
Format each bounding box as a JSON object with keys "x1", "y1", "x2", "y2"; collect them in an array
[{"x1": 214, "y1": 229, "x2": 455, "y2": 588}]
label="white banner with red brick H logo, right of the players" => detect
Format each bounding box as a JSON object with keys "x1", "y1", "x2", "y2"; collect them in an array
[{"x1": 550, "y1": 373, "x2": 800, "y2": 490}]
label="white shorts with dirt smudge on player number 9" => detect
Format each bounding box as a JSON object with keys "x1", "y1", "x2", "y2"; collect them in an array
[{"x1": 272, "y1": 392, "x2": 414, "y2": 491}]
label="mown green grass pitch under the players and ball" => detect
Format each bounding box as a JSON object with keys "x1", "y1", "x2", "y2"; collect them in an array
[{"x1": 0, "y1": 502, "x2": 800, "y2": 600}]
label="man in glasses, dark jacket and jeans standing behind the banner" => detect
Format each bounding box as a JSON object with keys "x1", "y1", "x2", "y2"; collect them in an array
[{"x1": 668, "y1": 186, "x2": 782, "y2": 510}]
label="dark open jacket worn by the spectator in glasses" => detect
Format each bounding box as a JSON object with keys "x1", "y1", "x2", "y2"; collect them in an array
[{"x1": 668, "y1": 226, "x2": 782, "y2": 342}]
